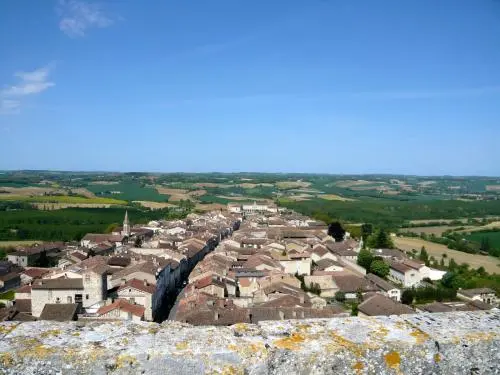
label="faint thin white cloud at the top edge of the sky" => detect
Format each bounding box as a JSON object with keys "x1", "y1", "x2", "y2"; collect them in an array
[{"x1": 57, "y1": 0, "x2": 113, "y2": 38}]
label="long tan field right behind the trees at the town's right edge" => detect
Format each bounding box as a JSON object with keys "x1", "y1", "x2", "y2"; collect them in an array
[{"x1": 394, "y1": 237, "x2": 500, "y2": 273}]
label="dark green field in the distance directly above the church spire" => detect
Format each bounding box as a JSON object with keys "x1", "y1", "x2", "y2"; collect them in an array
[{"x1": 86, "y1": 182, "x2": 168, "y2": 202}]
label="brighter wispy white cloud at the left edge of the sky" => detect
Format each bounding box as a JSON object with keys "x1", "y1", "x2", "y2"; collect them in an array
[{"x1": 0, "y1": 65, "x2": 55, "y2": 114}]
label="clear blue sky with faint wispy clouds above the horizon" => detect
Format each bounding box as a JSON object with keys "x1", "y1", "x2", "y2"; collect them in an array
[{"x1": 0, "y1": 0, "x2": 500, "y2": 176}]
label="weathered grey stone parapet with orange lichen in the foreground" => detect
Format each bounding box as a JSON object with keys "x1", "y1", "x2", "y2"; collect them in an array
[{"x1": 0, "y1": 311, "x2": 500, "y2": 375}]
